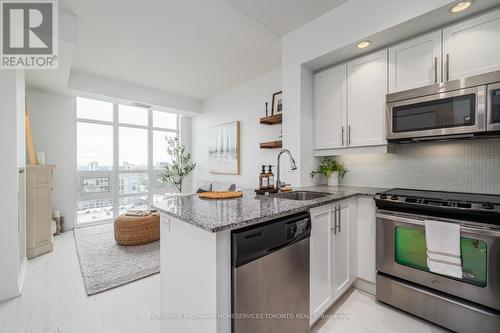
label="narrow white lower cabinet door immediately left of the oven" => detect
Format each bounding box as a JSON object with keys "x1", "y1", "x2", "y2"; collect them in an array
[{"x1": 358, "y1": 197, "x2": 376, "y2": 283}]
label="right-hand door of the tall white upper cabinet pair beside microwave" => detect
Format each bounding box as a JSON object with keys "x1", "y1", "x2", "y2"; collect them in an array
[{"x1": 347, "y1": 50, "x2": 387, "y2": 147}]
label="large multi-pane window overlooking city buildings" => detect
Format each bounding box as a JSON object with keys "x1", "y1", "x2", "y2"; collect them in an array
[{"x1": 76, "y1": 97, "x2": 179, "y2": 224}]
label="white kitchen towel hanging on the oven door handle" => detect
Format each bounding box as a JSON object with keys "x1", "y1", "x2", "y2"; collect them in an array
[{"x1": 425, "y1": 220, "x2": 462, "y2": 279}]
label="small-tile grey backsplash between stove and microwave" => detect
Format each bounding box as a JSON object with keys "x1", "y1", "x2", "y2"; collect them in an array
[{"x1": 336, "y1": 139, "x2": 500, "y2": 194}]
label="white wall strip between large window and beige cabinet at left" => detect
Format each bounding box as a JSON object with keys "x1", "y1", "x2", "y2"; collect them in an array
[{"x1": 26, "y1": 89, "x2": 76, "y2": 228}]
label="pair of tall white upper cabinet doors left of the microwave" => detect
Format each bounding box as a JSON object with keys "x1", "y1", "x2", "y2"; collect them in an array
[{"x1": 314, "y1": 50, "x2": 387, "y2": 150}]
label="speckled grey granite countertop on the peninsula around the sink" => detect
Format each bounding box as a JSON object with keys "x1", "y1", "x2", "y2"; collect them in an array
[{"x1": 156, "y1": 186, "x2": 385, "y2": 232}]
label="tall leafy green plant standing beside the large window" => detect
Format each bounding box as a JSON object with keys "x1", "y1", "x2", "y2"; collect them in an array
[{"x1": 161, "y1": 137, "x2": 196, "y2": 193}]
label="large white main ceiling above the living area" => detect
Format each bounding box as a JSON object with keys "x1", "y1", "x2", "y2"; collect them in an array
[{"x1": 27, "y1": 0, "x2": 352, "y2": 100}]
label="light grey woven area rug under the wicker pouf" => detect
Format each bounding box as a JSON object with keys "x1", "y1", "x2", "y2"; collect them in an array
[{"x1": 74, "y1": 223, "x2": 160, "y2": 296}]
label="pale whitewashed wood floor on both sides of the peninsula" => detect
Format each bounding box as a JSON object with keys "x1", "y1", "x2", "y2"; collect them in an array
[{"x1": 0, "y1": 232, "x2": 443, "y2": 333}]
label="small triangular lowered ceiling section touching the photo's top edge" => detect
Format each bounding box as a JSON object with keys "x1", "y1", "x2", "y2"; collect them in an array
[{"x1": 229, "y1": 0, "x2": 347, "y2": 36}]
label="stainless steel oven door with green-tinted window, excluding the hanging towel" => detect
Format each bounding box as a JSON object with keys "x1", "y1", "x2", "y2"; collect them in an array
[{"x1": 376, "y1": 210, "x2": 500, "y2": 310}]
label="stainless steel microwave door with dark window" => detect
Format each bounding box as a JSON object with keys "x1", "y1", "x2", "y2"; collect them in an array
[{"x1": 387, "y1": 86, "x2": 486, "y2": 140}]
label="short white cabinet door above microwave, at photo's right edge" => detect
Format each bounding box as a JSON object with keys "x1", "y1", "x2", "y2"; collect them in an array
[{"x1": 443, "y1": 10, "x2": 500, "y2": 81}]
